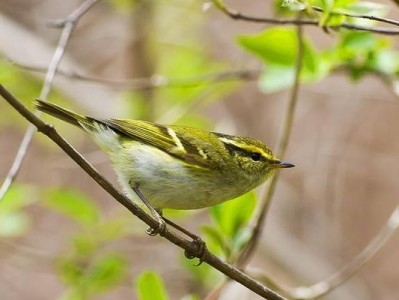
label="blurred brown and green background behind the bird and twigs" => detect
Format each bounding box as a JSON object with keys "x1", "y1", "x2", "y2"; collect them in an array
[{"x1": 0, "y1": 0, "x2": 399, "y2": 300}]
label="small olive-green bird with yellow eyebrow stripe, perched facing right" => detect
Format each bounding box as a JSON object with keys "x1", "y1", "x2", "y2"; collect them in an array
[{"x1": 37, "y1": 100, "x2": 294, "y2": 232}]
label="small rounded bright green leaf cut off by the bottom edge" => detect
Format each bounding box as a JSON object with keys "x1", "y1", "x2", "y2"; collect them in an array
[{"x1": 136, "y1": 271, "x2": 169, "y2": 300}]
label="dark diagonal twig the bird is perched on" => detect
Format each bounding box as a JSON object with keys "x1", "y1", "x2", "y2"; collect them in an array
[{"x1": 0, "y1": 85, "x2": 285, "y2": 300}]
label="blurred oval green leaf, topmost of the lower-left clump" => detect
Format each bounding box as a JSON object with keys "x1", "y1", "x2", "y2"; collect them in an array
[{"x1": 43, "y1": 189, "x2": 100, "y2": 226}]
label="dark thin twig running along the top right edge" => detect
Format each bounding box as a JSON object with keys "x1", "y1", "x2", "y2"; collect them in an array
[{"x1": 213, "y1": 0, "x2": 399, "y2": 35}]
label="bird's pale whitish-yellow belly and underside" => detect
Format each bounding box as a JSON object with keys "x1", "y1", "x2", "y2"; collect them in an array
[{"x1": 111, "y1": 145, "x2": 250, "y2": 210}]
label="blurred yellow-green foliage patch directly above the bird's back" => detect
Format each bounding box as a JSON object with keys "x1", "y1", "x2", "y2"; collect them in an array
[{"x1": 123, "y1": 0, "x2": 239, "y2": 128}]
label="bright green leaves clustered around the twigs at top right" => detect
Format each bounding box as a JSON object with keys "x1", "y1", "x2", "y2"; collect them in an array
[{"x1": 237, "y1": 0, "x2": 399, "y2": 93}]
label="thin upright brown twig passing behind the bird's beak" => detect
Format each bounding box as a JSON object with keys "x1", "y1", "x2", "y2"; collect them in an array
[{"x1": 237, "y1": 25, "x2": 304, "y2": 268}]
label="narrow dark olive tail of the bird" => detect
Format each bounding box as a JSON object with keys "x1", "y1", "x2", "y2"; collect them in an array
[{"x1": 36, "y1": 99, "x2": 98, "y2": 130}]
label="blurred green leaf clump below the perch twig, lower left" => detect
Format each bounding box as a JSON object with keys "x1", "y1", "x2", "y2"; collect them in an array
[{"x1": 42, "y1": 188, "x2": 133, "y2": 300}]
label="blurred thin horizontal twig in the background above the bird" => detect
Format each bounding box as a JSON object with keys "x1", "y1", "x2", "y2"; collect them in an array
[{"x1": 7, "y1": 59, "x2": 260, "y2": 90}]
